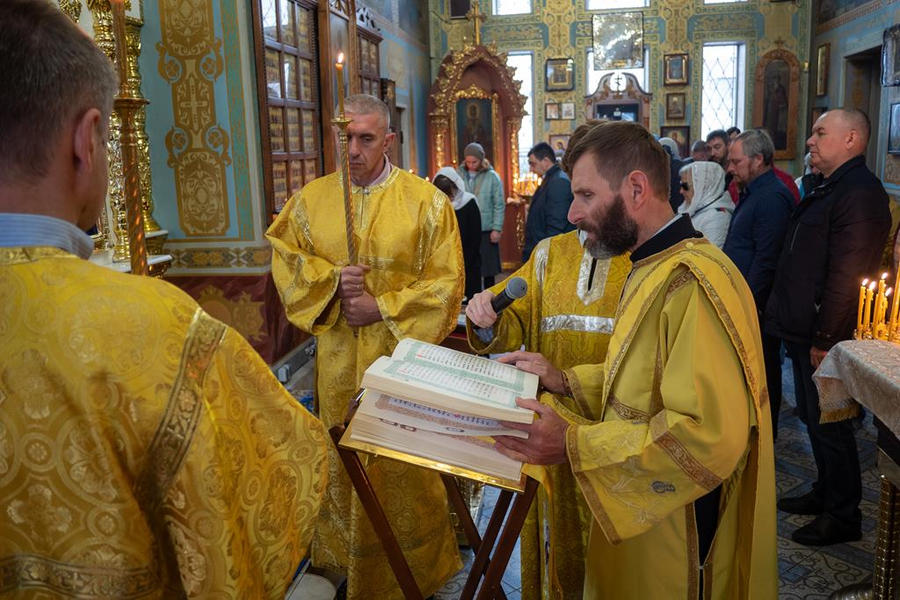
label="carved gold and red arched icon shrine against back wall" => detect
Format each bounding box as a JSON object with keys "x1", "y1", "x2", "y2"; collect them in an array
[{"x1": 428, "y1": 44, "x2": 526, "y2": 264}]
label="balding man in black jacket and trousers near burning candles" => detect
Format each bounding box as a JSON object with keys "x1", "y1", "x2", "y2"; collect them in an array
[{"x1": 766, "y1": 109, "x2": 891, "y2": 546}]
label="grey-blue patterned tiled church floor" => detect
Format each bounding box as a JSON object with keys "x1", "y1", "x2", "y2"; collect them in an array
[{"x1": 435, "y1": 361, "x2": 880, "y2": 600}]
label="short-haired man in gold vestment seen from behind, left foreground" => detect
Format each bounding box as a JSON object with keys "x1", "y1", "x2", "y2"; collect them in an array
[{"x1": 0, "y1": 0, "x2": 328, "y2": 599}]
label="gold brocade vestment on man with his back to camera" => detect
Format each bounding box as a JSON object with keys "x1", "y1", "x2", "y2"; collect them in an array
[{"x1": 0, "y1": 248, "x2": 327, "y2": 599}]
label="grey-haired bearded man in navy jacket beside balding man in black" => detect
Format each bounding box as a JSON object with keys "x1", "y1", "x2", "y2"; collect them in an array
[{"x1": 722, "y1": 129, "x2": 794, "y2": 437}]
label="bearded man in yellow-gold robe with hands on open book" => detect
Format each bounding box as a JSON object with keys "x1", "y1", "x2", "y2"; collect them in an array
[{"x1": 488, "y1": 121, "x2": 778, "y2": 600}]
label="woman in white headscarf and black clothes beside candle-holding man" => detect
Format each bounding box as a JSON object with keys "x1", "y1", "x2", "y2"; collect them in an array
[{"x1": 432, "y1": 167, "x2": 481, "y2": 300}]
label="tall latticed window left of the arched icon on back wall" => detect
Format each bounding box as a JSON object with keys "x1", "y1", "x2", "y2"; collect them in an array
[{"x1": 700, "y1": 42, "x2": 747, "y2": 136}]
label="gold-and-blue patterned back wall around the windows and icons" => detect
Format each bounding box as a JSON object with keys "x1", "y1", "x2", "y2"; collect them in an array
[{"x1": 429, "y1": 0, "x2": 810, "y2": 172}]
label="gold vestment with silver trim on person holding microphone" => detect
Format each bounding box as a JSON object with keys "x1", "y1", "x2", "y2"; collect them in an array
[{"x1": 467, "y1": 231, "x2": 631, "y2": 600}]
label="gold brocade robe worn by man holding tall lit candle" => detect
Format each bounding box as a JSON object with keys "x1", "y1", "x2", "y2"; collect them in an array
[{"x1": 266, "y1": 168, "x2": 464, "y2": 599}]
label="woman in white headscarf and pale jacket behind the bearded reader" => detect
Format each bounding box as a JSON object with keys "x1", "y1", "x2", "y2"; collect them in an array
[{"x1": 678, "y1": 162, "x2": 734, "y2": 248}]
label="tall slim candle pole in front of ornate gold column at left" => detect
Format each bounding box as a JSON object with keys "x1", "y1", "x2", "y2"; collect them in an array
[{"x1": 110, "y1": 0, "x2": 150, "y2": 275}]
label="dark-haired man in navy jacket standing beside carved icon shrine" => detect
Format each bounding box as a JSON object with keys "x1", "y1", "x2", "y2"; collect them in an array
[{"x1": 522, "y1": 142, "x2": 575, "y2": 262}]
